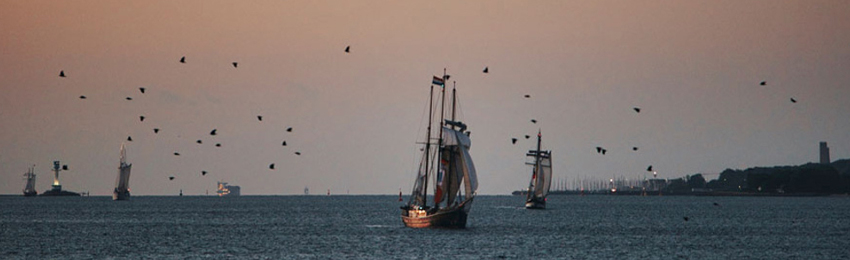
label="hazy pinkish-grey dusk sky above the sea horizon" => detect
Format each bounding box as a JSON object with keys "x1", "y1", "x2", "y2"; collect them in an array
[{"x1": 0, "y1": 0, "x2": 850, "y2": 195}]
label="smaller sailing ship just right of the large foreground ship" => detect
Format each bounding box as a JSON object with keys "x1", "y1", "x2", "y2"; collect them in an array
[{"x1": 525, "y1": 131, "x2": 552, "y2": 209}]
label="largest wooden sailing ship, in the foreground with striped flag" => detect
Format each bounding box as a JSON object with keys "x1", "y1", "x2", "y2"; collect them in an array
[{"x1": 401, "y1": 70, "x2": 478, "y2": 228}]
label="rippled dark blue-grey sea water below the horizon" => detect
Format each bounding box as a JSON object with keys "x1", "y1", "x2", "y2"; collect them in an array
[{"x1": 0, "y1": 196, "x2": 850, "y2": 259}]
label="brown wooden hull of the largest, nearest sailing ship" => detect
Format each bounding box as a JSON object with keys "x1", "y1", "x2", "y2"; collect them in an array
[{"x1": 401, "y1": 200, "x2": 472, "y2": 228}]
